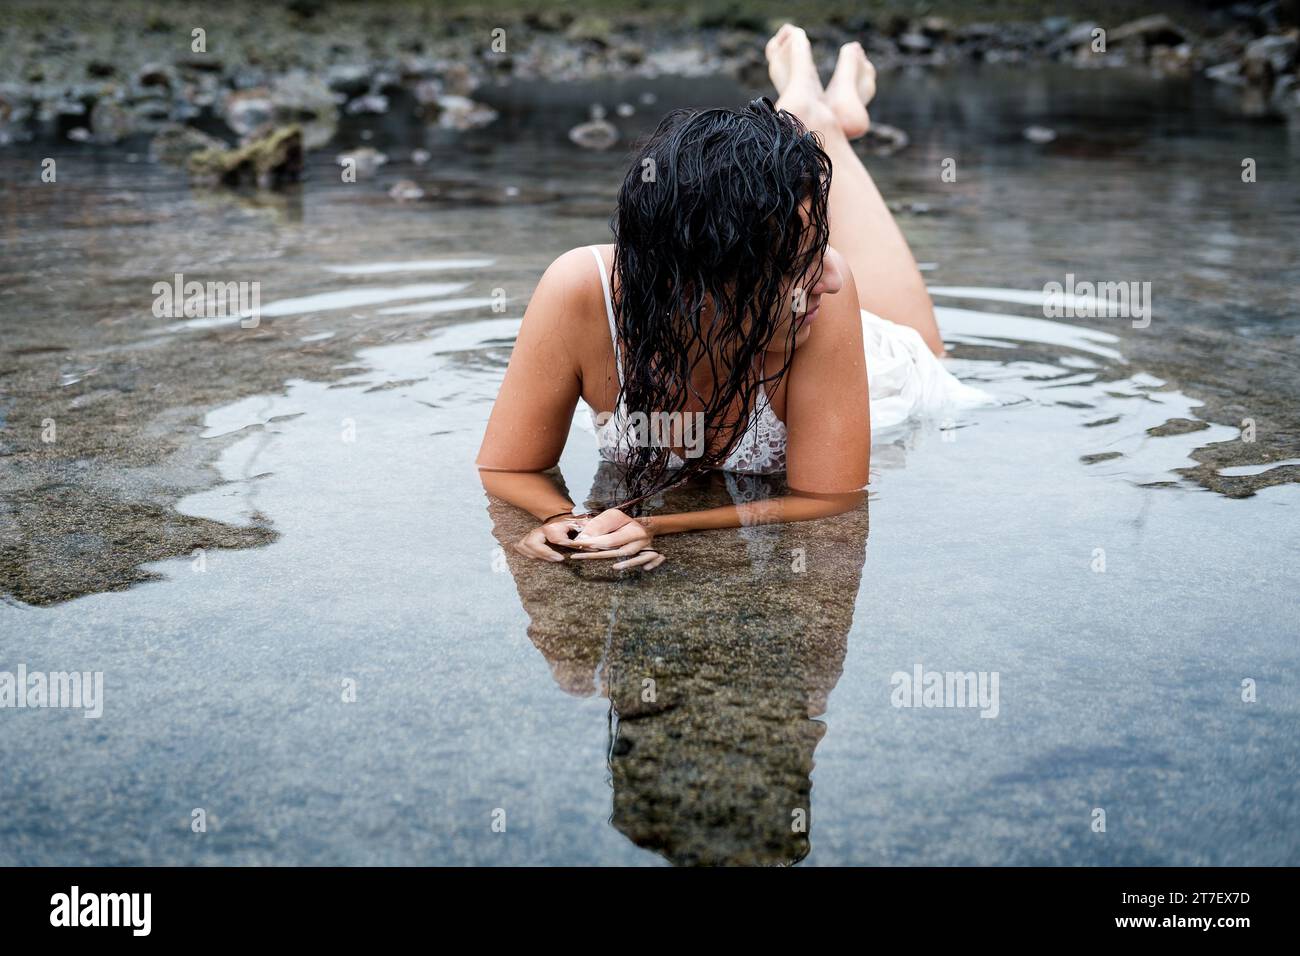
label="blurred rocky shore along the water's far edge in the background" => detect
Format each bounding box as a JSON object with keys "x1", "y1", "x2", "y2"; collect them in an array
[{"x1": 0, "y1": 0, "x2": 1300, "y2": 169}]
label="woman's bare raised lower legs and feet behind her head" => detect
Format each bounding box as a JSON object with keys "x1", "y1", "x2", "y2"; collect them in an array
[{"x1": 767, "y1": 23, "x2": 944, "y2": 355}]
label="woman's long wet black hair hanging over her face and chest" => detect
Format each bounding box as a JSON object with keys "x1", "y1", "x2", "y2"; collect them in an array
[{"x1": 612, "y1": 98, "x2": 831, "y2": 512}]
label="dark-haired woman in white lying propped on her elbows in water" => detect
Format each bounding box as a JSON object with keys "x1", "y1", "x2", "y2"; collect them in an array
[{"x1": 478, "y1": 25, "x2": 984, "y2": 570}]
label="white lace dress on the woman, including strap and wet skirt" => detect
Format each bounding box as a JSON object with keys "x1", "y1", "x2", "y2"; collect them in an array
[{"x1": 588, "y1": 246, "x2": 996, "y2": 475}]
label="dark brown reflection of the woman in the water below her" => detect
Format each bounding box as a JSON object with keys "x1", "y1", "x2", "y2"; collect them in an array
[{"x1": 489, "y1": 463, "x2": 867, "y2": 865}]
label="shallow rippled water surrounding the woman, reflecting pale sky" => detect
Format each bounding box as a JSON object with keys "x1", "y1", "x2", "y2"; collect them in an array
[{"x1": 0, "y1": 63, "x2": 1300, "y2": 864}]
